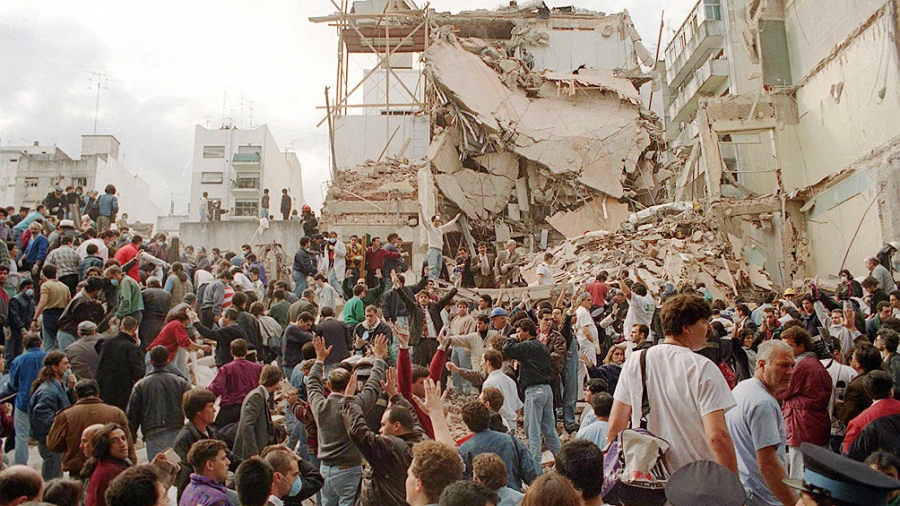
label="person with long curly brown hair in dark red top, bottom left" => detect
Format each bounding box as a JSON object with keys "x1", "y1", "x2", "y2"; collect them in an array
[{"x1": 81, "y1": 423, "x2": 134, "y2": 506}]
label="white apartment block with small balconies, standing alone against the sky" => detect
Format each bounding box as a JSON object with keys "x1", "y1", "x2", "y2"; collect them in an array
[{"x1": 190, "y1": 125, "x2": 305, "y2": 221}]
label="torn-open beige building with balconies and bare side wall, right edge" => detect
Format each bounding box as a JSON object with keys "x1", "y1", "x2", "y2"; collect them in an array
[{"x1": 658, "y1": 0, "x2": 900, "y2": 286}]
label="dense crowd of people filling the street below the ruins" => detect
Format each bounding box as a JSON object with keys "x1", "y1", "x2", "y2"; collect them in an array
[{"x1": 0, "y1": 191, "x2": 900, "y2": 506}]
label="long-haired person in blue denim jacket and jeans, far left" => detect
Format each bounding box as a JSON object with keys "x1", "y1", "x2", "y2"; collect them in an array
[{"x1": 28, "y1": 351, "x2": 75, "y2": 481}]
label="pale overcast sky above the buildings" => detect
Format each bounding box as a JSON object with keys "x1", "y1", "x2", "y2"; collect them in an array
[{"x1": 0, "y1": 0, "x2": 695, "y2": 213}]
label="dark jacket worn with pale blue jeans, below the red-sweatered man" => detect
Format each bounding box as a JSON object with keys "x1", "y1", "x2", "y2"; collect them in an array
[{"x1": 125, "y1": 368, "x2": 191, "y2": 439}]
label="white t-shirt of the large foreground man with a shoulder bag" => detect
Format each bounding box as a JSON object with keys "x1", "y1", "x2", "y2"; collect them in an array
[{"x1": 613, "y1": 344, "x2": 735, "y2": 472}]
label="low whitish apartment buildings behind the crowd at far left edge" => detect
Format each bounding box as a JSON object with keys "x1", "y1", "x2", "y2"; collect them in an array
[{"x1": 0, "y1": 135, "x2": 164, "y2": 223}]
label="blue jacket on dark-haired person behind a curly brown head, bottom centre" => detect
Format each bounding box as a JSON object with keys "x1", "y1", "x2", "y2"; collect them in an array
[{"x1": 459, "y1": 430, "x2": 541, "y2": 491}]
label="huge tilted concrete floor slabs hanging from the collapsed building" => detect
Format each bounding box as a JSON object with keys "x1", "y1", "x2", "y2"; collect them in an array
[{"x1": 423, "y1": 27, "x2": 672, "y2": 240}]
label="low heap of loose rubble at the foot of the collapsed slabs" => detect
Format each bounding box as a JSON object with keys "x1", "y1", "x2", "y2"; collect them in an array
[{"x1": 522, "y1": 202, "x2": 772, "y2": 300}]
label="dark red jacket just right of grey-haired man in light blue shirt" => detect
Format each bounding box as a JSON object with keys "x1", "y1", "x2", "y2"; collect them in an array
[{"x1": 779, "y1": 354, "x2": 832, "y2": 446}]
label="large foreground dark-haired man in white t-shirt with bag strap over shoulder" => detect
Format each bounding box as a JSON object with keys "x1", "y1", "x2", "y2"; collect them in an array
[{"x1": 606, "y1": 292, "x2": 738, "y2": 475}]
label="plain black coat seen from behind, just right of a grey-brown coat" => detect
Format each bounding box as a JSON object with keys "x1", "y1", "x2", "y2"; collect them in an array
[{"x1": 94, "y1": 332, "x2": 144, "y2": 412}]
